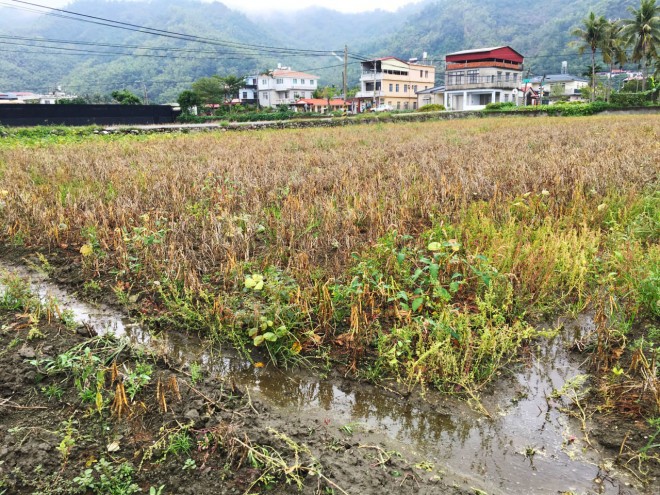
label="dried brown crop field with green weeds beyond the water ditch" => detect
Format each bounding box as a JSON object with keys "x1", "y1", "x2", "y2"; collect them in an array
[{"x1": 0, "y1": 116, "x2": 660, "y2": 411}]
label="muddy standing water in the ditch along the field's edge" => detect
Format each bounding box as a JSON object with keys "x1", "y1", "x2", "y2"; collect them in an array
[{"x1": 0, "y1": 263, "x2": 644, "y2": 495}]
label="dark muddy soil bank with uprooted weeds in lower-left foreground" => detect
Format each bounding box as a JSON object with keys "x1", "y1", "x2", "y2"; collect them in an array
[{"x1": 0, "y1": 312, "x2": 474, "y2": 494}]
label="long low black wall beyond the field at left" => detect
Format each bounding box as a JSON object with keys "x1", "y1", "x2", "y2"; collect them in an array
[{"x1": 0, "y1": 104, "x2": 179, "y2": 127}]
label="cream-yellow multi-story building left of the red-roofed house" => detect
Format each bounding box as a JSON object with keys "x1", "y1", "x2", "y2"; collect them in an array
[{"x1": 355, "y1": 57, "x2": 435, "y2": 111}]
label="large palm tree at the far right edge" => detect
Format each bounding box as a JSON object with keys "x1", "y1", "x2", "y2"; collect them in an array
[{"x1": 621, "y1": 0, "x2": 660, "y2": 91}]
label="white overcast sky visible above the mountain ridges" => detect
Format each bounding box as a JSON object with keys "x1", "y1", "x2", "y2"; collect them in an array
[{"x1": 15, "y1": 0, "x2": 420, "y2": 12}]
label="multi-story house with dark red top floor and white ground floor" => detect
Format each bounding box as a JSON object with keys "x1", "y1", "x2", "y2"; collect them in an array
[{"x1": 445, "y1": 46, "x2": 524, "y2": 110}]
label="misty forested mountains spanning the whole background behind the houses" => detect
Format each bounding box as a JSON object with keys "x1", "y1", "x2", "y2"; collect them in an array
[{"x1": 0, "y1": 0, "x2": 639, "y2": 102}]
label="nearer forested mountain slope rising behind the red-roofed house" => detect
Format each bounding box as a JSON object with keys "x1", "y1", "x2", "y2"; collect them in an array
[{"x1": 376, "y1": 0, "x2": 639, "y2": 80}]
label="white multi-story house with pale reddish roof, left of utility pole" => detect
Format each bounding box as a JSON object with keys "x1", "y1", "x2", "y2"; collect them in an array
[{"x1": 257, "y1": 67, "x2": 319, "y2": 107}]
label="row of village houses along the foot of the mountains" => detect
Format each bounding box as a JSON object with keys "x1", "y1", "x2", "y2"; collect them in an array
[{"x1": 0, "y1": 46, "x2": 641, "y2": 113}]
